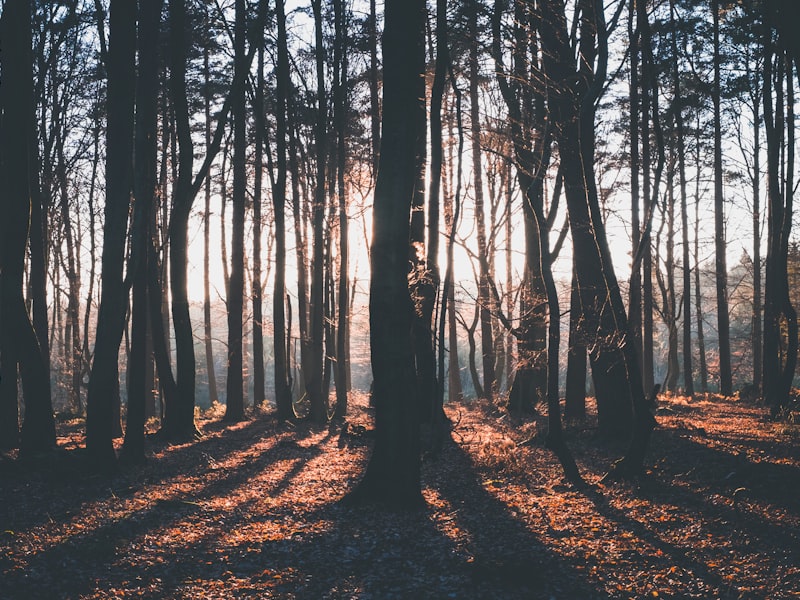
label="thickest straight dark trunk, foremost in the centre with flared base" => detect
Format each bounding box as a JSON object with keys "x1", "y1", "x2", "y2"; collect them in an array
[{"x1": 350, "y1": 0, "x2": 426, "y2": 507}]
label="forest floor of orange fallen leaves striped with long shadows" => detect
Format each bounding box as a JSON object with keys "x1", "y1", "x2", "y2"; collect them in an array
[{"x1": 0, "y1": 396, "x2": 800, "y2": 600}]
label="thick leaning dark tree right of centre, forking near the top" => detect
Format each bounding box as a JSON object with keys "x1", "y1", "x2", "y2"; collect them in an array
[{"x1": 541, "y1": 0, "x2": 654, "y2": 477}]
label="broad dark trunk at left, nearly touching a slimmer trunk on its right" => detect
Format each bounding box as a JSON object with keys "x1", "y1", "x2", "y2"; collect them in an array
[{"x1": 86, "y1": 0, "x2": 136, "y2": 468}]
